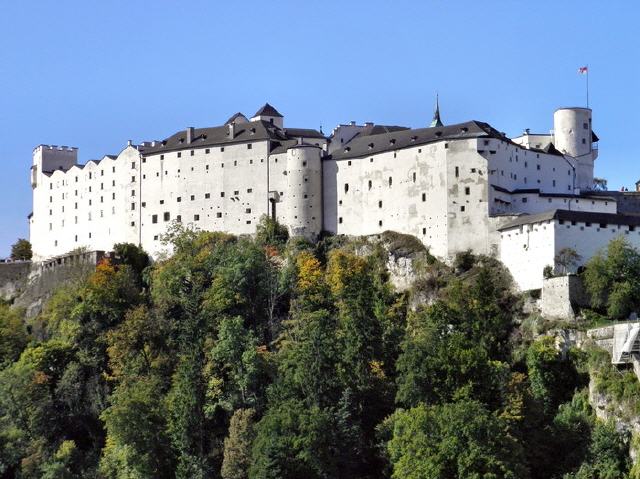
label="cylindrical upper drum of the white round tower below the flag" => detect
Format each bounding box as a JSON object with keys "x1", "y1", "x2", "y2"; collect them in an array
[{"x1": 553, "y1": 108, "x2": 592, "y2": 158}]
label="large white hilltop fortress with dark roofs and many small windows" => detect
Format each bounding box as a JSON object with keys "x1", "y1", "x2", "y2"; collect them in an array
[{"x1": 29, "y1": 104, "x2": 640, "y2": 290}]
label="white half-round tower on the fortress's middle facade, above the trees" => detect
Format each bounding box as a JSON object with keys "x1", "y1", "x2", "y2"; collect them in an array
[{"x1": 286, "y1": 144, "x2": 322, "y2": 239}]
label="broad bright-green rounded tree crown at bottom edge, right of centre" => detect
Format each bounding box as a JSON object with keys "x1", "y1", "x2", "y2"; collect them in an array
[{"x1": 387, "y1": 400, "x2": 529, "y2": 479}]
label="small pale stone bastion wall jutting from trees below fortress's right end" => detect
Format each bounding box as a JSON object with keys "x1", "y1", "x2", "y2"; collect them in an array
[{"x1": 541, "y1": 275, "x2": 589, "y2": 319}]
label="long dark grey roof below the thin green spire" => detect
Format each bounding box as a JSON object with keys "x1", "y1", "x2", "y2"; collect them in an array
[{"x1": 331, "y1": 121, "x2": 511, "y2": 160}]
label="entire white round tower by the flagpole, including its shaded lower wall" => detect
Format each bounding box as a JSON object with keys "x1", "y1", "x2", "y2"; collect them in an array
[{"x1": 553, "y1": 107, "x2": 598, "y2": 190}]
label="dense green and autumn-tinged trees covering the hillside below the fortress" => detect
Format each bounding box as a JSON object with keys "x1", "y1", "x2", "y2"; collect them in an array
[{"x1": 0, "y1": 220, "x2": 631, "y2": 479}]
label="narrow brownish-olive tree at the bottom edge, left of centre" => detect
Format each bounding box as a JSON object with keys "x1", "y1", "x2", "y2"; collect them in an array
[{"x1": 220, "y1": 409, "x2": 255, "y2": 479}]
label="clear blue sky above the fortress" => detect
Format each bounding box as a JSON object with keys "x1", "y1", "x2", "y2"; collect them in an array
[{"x1": 0, "y1": 0, "x2": 640, "y2": 257}]
